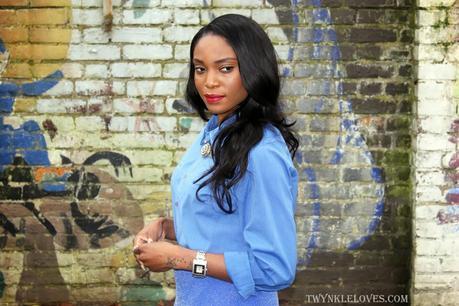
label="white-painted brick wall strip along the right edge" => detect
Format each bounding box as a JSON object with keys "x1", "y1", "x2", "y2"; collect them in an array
[{"x1": 412, "y1": 1, "x2": 459, "y2": 305}]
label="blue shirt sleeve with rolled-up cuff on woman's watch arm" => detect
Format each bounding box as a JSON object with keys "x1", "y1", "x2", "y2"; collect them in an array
[{"x1": 224, "y1": 142, "x2": 298, "y2": 298}]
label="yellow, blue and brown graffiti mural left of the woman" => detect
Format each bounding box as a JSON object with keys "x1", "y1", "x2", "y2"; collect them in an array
[{"x1": 0, "y1": 3, "x2": 149, "y2": 303}]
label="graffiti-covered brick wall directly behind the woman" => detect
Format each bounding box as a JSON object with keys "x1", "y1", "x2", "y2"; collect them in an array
[{"x1": 0, "y1": 0, "x2": 415, "y2": 305}]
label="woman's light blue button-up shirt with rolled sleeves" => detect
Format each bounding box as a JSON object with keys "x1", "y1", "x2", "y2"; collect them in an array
[{"x1": 171, "y1": 115, "x2": 298, "y2": 300}]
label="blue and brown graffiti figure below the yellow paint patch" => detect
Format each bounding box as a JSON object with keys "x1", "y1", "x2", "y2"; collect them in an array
[{"x1": 0, "y1": 49, "x2": 143, "y2": 302}]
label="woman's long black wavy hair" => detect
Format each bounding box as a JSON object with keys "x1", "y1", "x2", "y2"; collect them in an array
[{"x1": 186, "y1": 14, "x2": 298, "y2": 213}]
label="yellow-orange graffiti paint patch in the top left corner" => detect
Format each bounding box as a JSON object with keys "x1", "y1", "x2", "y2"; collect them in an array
[{"x1": 0, "y1": 0, "x2": 71, "y2": 79}]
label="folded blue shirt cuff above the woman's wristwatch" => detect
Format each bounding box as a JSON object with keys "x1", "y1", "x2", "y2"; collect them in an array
[{"x1": 223, "y1": 252, "x2": 255, "y2": 299}]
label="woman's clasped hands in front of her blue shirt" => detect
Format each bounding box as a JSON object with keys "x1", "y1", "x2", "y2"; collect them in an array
[{"x1": 134, "y1": 241, "x2": 187, "y2": 272}]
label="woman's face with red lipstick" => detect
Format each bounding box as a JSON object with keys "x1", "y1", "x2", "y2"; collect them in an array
[{"x1": 193, "y1": 35, "x2": 247, "y2": 122}]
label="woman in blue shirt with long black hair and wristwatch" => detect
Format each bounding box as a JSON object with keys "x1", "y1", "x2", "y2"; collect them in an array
[{"x1": 134, "y1": 14, "x2": 298, "y2": 305}]
